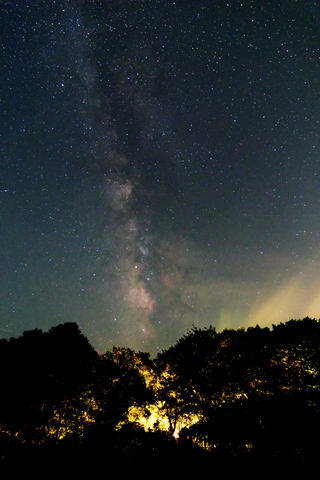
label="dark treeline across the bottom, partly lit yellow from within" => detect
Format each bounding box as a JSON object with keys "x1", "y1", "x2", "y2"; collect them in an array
[{"x1": 0, "y1": 318, "x2": 320, "y2": 472}]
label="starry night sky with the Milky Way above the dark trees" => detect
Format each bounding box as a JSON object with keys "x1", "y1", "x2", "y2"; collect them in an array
[{"x1": 0, "y1": 0, "x2": 320, "y2": 352}]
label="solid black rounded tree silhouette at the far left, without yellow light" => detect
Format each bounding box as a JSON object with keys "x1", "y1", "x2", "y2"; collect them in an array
[{"x1": 0, "y1": 323, "x2": 97, "y2": 441}]
